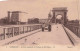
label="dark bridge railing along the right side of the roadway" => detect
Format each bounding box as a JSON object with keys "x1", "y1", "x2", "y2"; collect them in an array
[{"x1": 65, "y1": 24, "x2": 80, "y2": 37}]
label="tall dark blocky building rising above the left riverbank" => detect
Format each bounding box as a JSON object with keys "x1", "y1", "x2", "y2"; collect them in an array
[{"x1": 8, "y1": 11, "x2": 20, "y2": 24}]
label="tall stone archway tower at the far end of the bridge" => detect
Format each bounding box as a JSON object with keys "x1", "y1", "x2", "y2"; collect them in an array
[{"x1": 52, "y1": 7, "x2": 67, "y2": 25}]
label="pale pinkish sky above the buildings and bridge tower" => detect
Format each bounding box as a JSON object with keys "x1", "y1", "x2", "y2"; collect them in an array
[{"x1": 0, "y1": 0, "x2": 80, "y2": 21}]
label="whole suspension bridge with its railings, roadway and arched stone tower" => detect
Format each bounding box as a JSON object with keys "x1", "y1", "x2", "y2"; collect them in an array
[{"x1": 0, "y1": 8, "x2": 80, "y2": 45}]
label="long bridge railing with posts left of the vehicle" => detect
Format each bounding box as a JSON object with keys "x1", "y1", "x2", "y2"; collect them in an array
[{"x1": 0, "y1": 24, "x2": 42, "y2": 40}]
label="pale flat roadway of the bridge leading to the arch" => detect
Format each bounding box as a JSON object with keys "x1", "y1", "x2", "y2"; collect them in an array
[{"x1": 12, "y1": 24, "x2": 72, "y2": 45}]
